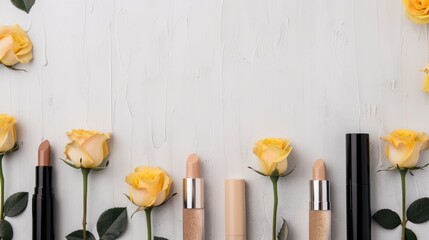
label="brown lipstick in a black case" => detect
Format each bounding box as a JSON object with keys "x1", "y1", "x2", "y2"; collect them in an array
[{"x1": 33, "y1": 140, "x2": 55, "y2": 240}]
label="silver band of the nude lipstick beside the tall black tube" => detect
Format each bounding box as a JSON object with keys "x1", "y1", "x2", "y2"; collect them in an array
[{"x1": 310, "y1": 180, "x2": 331, "y2": 211}]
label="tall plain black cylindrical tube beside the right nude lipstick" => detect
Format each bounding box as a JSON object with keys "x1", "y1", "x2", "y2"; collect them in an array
[{"x1": 346, "y1": 133, "x2": 371, "y2": 240}]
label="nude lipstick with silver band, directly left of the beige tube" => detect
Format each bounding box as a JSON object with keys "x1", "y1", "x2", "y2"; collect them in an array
[{"x1": 183, "y1": 154, "x2": 204, "y2": 240}]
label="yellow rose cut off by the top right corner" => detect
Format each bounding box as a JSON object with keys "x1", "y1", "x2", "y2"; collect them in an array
[{"x1": 402, "y1": 0, "x2": 429, "y2": 24}]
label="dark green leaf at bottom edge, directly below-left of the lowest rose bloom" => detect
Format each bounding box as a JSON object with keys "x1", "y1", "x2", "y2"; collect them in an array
[{"x1": 97, "y1": 208, "x2": 128, "y2": 240}]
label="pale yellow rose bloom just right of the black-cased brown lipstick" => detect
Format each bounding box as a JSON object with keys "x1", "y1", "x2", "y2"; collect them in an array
[{"x1": 64, "y1": 130, "x2": 110, "y2": 168}]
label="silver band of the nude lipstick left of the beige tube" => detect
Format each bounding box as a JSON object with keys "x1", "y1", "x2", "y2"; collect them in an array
[{"x1": 183, "y1": 178, "x2": 204, "y2": 209}]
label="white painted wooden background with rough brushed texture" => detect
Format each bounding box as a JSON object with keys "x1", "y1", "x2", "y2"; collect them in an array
[{"x1": 0, "y1": 0, "x2": 429, "y2": 240}]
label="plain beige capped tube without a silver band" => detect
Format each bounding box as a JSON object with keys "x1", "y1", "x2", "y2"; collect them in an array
[{"x1": 225, "y1": 179, "x2": 246, "y2": 240}]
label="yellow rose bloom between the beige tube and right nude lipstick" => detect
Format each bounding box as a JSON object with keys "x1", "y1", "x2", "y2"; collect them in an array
[{"x1": 253, "y1": 138, "x2": 292, "y2": 176}]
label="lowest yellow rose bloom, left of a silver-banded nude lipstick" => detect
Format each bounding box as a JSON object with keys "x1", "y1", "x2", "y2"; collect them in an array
[{"x1": 125, "y1": 166, "x2": 173, "y2": 208}]
